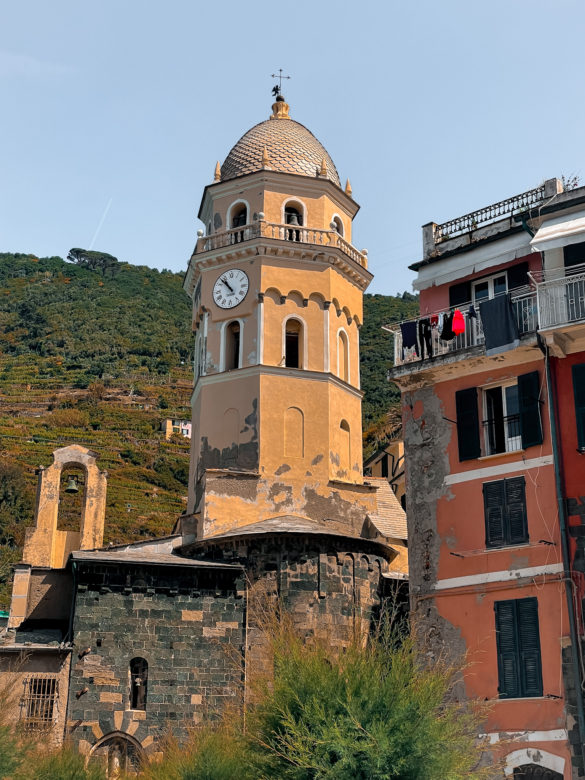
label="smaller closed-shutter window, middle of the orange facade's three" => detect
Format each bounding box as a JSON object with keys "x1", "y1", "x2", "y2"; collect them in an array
[{"x1": 483, "y1": 477, "x2": 528, "y2": 547}]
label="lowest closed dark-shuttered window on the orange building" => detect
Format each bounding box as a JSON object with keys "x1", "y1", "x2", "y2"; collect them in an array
[{"x1": 494, "y1": 597, "x2": 542, "y2": 699}]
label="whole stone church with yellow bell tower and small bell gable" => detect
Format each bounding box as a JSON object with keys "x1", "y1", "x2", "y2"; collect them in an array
[{"x1": 0, "y1": 95, "x2": 407, "y2": 776}]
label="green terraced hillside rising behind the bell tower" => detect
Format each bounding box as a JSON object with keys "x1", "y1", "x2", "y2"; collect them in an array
[{"x1": 0, "y1": 254, "x2": 417, "y2": 608}]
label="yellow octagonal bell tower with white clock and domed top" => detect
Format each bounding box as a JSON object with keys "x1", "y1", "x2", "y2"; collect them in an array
[{"x1": 185, "y1": 95, "x2": 375, "y2": 537}]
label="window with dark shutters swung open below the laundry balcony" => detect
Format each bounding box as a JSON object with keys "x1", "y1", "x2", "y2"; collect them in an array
[{"x1": 455, "y1": 371, "x2": 543, "y2": 461}]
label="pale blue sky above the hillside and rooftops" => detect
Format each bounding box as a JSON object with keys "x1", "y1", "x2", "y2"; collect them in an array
[{"x1": 0, "y1": 0, "x2": 585, "y2": 295}]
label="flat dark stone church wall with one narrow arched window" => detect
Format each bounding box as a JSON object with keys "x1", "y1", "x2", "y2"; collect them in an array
[{"x1": 68, "y1": 563, "x2": 246, "y2": 752}]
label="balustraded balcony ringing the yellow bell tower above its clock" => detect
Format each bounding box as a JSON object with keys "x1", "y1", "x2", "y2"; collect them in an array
[{"x1": 193, "y1": 220, "x2": 368, "y2": 268}]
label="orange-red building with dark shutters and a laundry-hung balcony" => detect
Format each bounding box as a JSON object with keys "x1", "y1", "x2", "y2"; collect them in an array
[{"x1": 389, "y1": 179, "x2": 585, "y2": 780}]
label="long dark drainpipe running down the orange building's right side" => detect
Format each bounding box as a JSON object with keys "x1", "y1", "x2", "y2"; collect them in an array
[{"x1": 544, "y1": 345, "x2": 585, "y2": 765}]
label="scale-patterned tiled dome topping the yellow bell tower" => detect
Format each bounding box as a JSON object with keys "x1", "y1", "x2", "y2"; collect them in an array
[{"x1": 221, "y1": 95, "x2": 341, "y2": 187}]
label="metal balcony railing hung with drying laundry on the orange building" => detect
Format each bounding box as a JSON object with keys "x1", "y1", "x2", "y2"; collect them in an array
[{"x1": 384, "y1": 291, "x2": 538, "y2": 366}]
